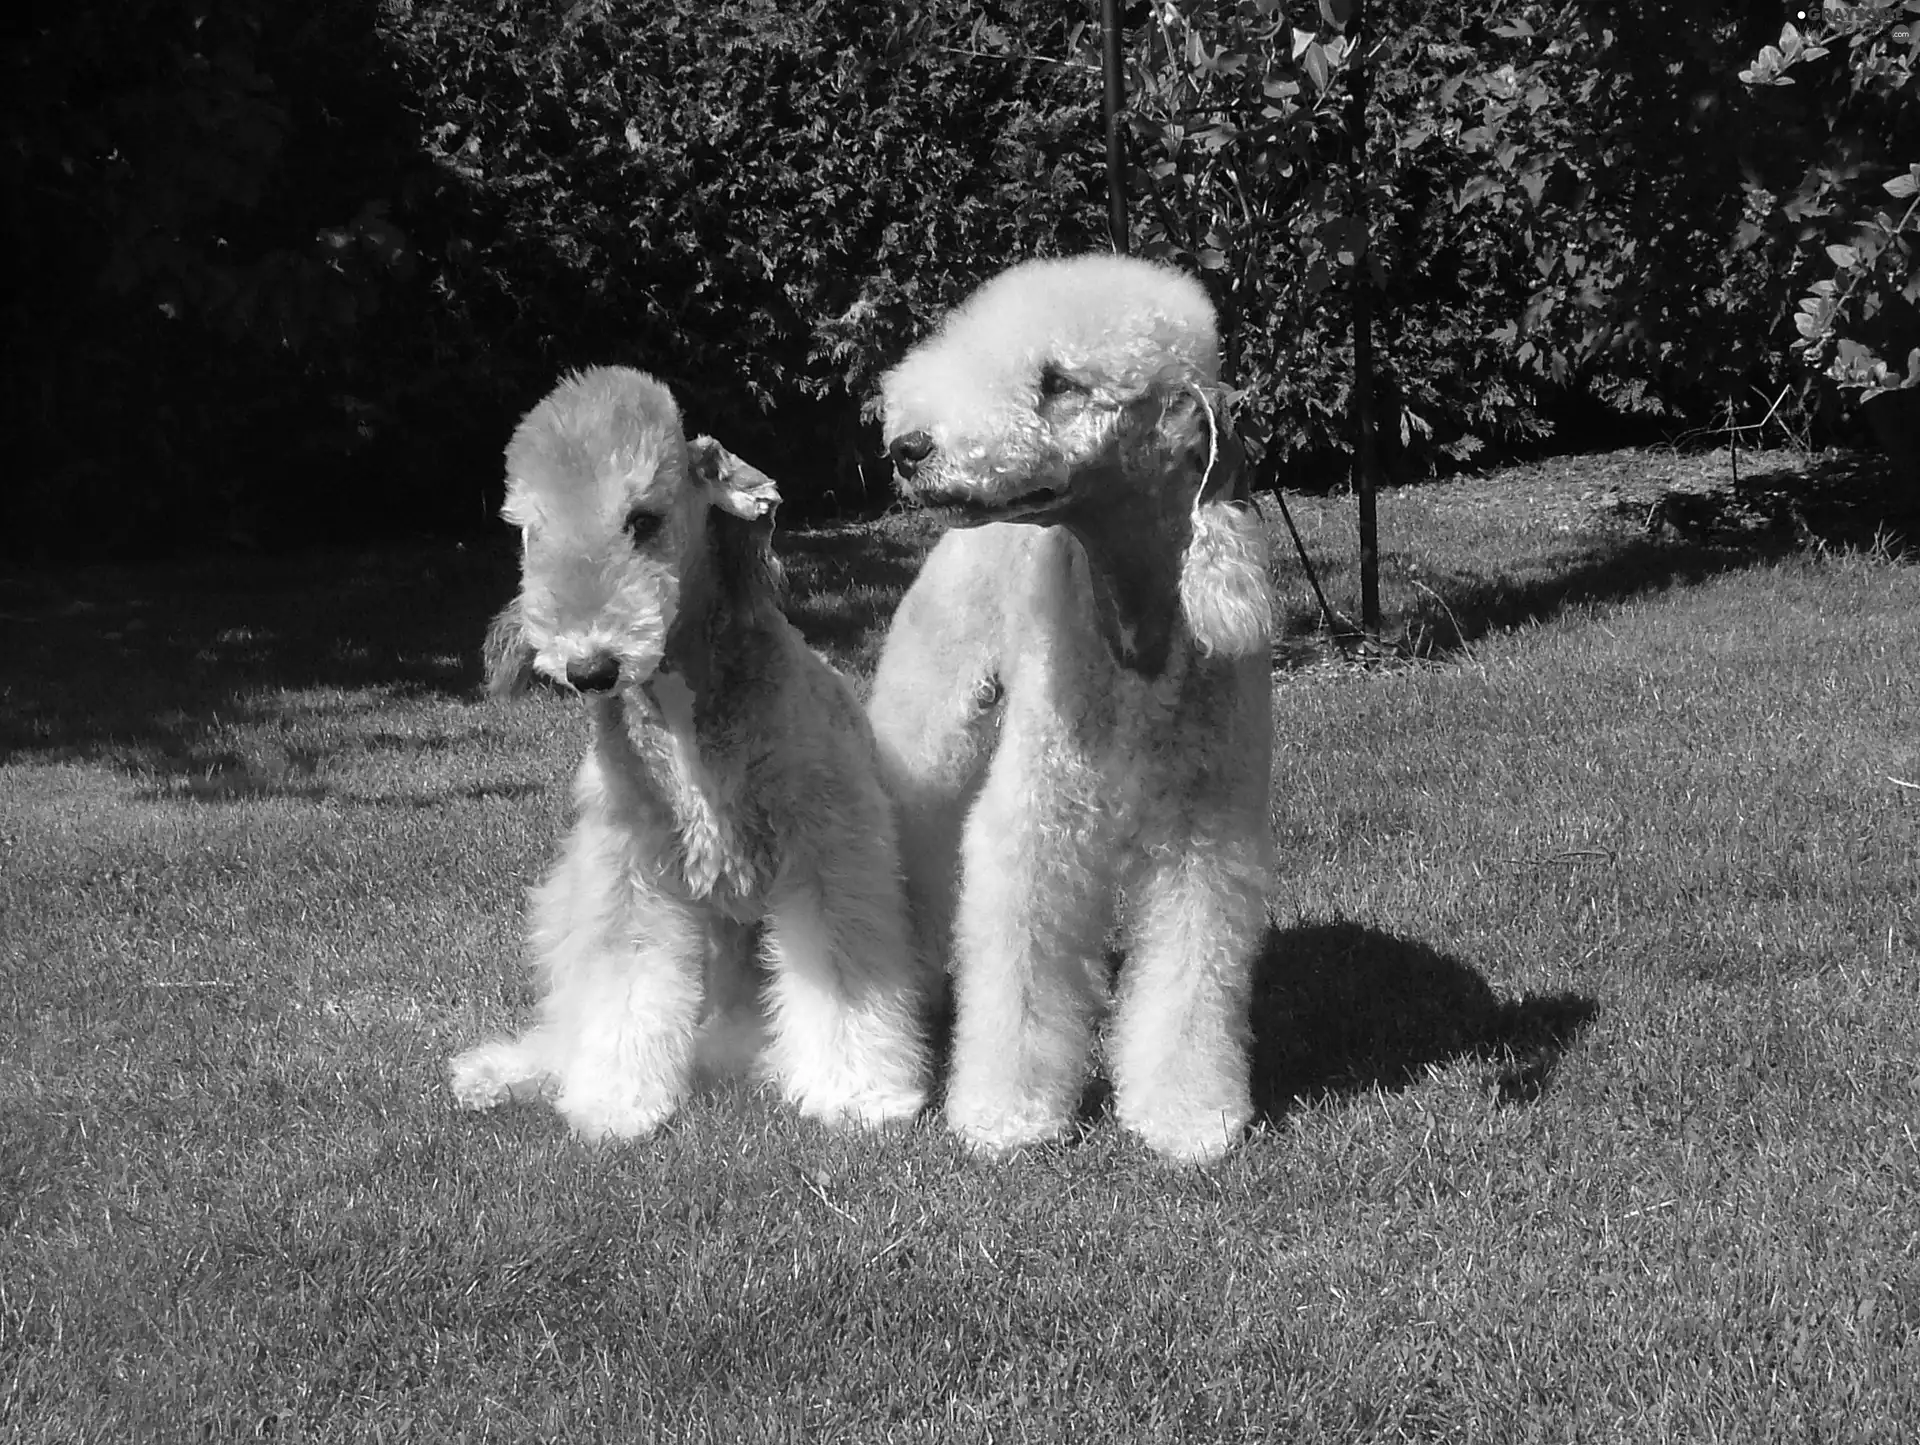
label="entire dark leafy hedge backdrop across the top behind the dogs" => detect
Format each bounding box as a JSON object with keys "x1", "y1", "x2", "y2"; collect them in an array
[{"x1": 0, "y1": 0, "x2": 1912, "y2": 557}]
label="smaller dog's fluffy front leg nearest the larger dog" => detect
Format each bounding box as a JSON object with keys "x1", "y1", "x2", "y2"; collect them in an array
[{"x1": 766, "y1": 833, "x2": 931, "y2": 1125}]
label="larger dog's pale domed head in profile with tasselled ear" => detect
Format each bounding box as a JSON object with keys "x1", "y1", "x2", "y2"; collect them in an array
[{"x1": 879, "y1": 255, "x2": 1271, "y2": 656}]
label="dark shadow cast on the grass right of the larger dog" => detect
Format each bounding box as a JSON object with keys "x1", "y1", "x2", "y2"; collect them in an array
[{"x1": 1252, "y1": 923, "x2": 1597, "y2": 1119}]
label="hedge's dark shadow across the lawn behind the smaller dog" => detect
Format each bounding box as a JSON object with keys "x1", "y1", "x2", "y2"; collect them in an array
[{"x1": 0, "y1": 522, "x2": 939, "y2": 767}]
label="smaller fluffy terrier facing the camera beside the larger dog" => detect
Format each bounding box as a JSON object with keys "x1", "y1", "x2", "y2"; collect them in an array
[{"x1": 451, "y1": 367, "x2": 933, "y2": 1138}]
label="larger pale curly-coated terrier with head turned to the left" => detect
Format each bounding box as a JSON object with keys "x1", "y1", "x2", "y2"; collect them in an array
[{"x1": 870, "y1": 257, "x2": 1273, "y2": 1161}]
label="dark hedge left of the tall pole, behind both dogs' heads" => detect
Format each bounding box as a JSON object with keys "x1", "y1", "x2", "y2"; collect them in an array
[{"x1": 0, "y1": 0, "x2": 1100, "y2": 553}]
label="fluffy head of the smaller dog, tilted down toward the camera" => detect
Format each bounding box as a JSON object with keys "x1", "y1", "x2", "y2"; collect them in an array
[{"x1": 486, "y1": 367, "x2": 780, "y2": 693}]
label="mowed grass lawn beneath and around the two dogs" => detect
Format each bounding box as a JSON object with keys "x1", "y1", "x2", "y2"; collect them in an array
[{"x1": 0, "y1": 455, "x2": 1920, "y2": 1441}]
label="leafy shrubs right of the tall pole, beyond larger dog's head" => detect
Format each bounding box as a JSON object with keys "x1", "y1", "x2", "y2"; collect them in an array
[{"x1": 1133, "y1": 0, "x2": 1866, "y2": 485}]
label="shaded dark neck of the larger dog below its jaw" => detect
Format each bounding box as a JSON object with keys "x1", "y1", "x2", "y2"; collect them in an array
[{"x1": 1050, "y1": 462, "x2": 1192, "y2": 677}]
